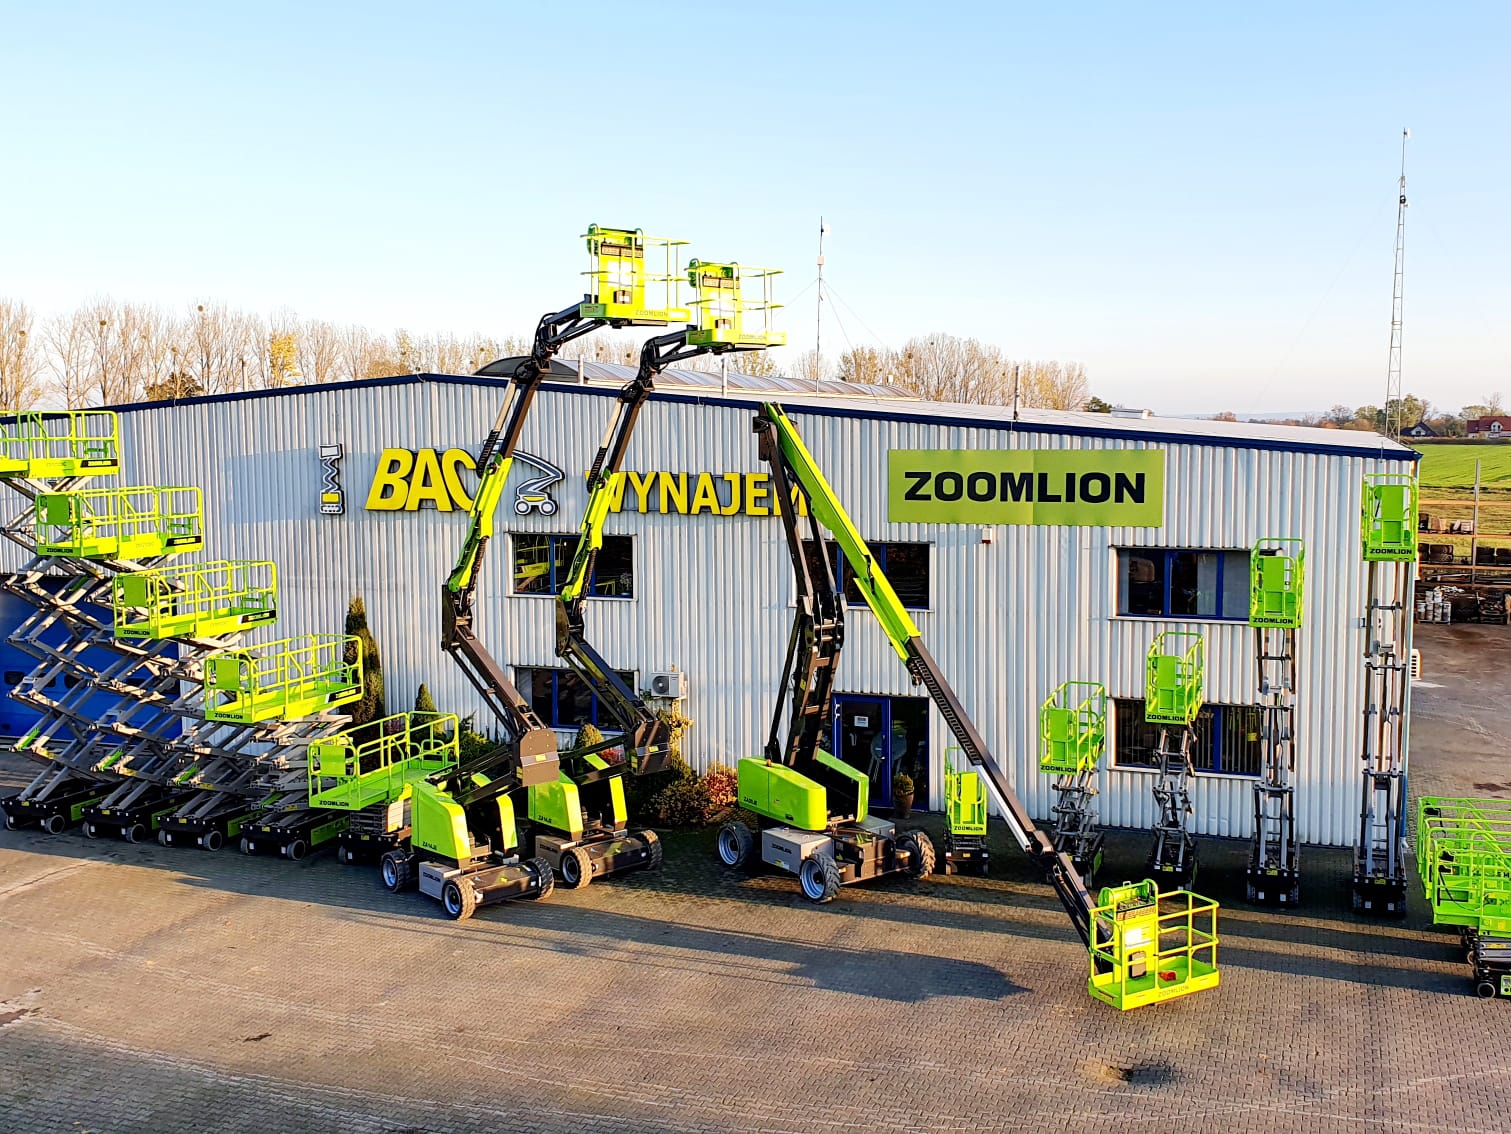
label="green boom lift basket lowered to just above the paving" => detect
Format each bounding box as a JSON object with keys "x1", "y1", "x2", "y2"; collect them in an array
[{"x1": 1086, "y1": 878, "x2": 1218, "y2": 1012}]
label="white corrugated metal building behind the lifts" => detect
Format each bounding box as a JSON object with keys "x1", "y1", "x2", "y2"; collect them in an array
[{"x1": 71, "y1": 364, "x2": 1416, "y2": 845}]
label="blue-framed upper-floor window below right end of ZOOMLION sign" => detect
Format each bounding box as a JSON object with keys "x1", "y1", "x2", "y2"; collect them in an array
[{"x1": 1118, "y1": 547, "x2": 1248, "y2": 621}]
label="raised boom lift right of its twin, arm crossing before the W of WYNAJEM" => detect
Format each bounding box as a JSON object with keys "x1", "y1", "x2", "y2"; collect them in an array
[{"x1": 543, "y1": 260, "x2": 787, "y2": 886}]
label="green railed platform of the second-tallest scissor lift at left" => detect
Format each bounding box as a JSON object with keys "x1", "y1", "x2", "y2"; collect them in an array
[{"x1": 35, "y1": 487, "x2": 204, "y2": 559}]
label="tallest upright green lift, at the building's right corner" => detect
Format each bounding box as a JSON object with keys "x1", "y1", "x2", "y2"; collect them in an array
[{"x1": 1352, "y1": 473, "x2": 1417, "y2": 915}]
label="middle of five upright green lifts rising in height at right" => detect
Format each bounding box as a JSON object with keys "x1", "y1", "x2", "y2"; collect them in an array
[{"x1": 1144, "y1": 631, "x2": 1206, "y2": 888}]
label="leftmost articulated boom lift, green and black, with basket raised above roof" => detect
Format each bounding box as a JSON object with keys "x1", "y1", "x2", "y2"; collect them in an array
[{"x1": 382, "y1": 225, "x2": 689, "y2": 919}]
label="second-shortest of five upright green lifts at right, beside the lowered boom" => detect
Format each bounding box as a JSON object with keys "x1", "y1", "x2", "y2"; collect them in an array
[{"x1": 1040, "y1": 682, "x2": 1108, "y2": 888}]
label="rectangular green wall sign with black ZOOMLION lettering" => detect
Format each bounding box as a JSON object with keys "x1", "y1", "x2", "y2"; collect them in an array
[{"x1": 887, "y1": 449, "x2": 1165, "y2": 528}]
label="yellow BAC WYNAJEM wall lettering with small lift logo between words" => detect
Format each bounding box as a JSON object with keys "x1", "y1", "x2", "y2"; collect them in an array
[{"x1": 366, "y1": 449, "x2": 804, "y2": 516}]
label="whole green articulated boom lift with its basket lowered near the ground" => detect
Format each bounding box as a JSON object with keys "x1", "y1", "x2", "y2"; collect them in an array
[{"x1": 719, "y1": 404, "x2": 1218, "y2": 1009}]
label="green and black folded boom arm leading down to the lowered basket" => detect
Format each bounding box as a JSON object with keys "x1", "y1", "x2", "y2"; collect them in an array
[{"x1": 756, "y1": 402, "x2": 1095, "y2": 945}]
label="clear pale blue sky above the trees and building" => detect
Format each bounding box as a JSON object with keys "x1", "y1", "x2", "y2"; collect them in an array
[{"x1": 0, "y1": 0, "x2": 1511, "y2": 413}]
